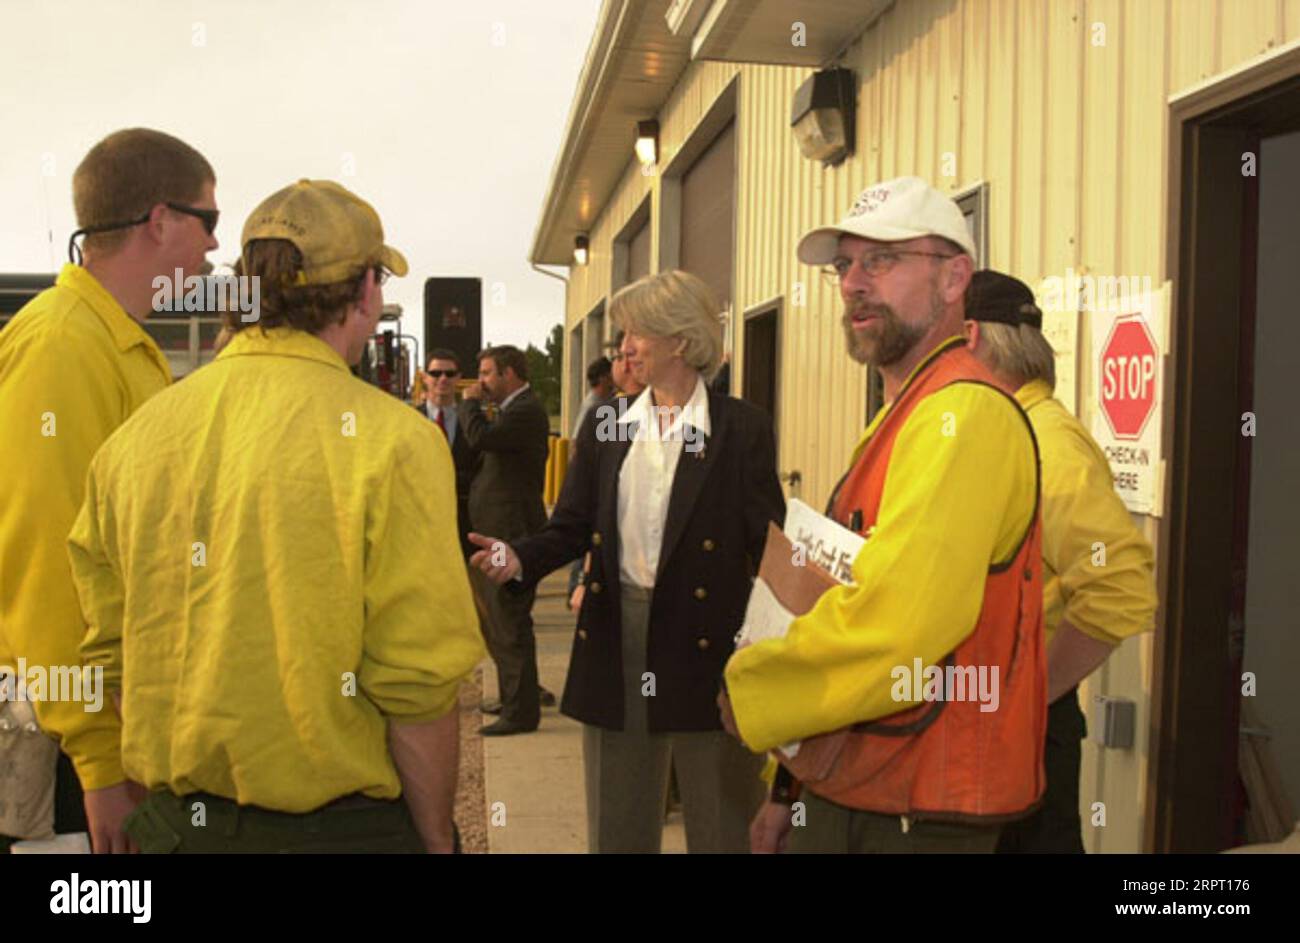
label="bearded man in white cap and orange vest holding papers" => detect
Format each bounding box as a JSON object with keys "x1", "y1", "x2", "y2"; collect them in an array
[{"x1": 720, "y1": 177, "x2": 1045, "y2": 852}]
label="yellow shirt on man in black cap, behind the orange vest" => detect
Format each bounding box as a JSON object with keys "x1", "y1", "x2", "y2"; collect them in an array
[{"x1": 1015, "y1": 380, "x2": 1156, "y2": 645}]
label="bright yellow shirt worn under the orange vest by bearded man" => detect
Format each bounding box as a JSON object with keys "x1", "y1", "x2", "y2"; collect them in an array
[{"x1": 725, "y1": 356, "x2": 1036, "y2": 750}]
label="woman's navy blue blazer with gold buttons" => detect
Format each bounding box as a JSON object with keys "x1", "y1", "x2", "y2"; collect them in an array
[{"x1": 511, "y1": 390, "x2": 785, "y2": 732}]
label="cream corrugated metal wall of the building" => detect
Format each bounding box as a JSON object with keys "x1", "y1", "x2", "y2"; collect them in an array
[{"x1": 567, "y1": 0, "x2": 1300, "y2": 851}]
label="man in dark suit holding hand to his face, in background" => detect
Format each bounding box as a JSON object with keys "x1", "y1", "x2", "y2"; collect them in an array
[{"x1": 459, "y1": 346, "x2": 550, "y2": 736}]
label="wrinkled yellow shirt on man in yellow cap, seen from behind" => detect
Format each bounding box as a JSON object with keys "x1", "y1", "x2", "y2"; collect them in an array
[{"x1": 69, "y1": 326, "x2": 484, "y2": 812}]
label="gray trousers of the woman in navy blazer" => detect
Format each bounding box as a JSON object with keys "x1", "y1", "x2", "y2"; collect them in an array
[{"x1": 582, "y1": 587, "x2": 764, "y2": 855}]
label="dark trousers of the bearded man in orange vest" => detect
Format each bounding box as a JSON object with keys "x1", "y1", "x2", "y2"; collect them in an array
[{"x1": 788, "y1": 790, "x2": 1002, "y2": 855}]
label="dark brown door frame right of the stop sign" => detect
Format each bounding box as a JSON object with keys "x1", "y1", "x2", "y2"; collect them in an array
[{"x1": 1144, "y1": 42, "x2": 1300, "y2": 852}]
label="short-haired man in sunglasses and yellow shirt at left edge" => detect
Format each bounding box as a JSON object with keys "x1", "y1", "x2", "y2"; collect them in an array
[{"x1": 0, "y1": 127, "x2": 217, "y2": 852}]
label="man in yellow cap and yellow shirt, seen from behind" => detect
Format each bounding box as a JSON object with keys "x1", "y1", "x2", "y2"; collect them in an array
[{"x1": 69, "y1": 179, "x2": 484, "y2": 852}]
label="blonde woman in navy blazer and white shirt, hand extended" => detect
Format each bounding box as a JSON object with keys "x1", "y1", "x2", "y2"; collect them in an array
[{"x1": 472, "y1": 272, "x2": 785, "y2": 852}]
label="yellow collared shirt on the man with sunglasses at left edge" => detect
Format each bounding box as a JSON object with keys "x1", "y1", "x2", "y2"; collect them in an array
[{"x1": 0, "y1": 265, "x2": 172, "y2": 790}]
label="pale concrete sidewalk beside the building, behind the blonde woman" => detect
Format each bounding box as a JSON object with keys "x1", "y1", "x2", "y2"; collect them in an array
[{"x1": 484, "y1": 568, "x2": 686, "y2": 853}]
